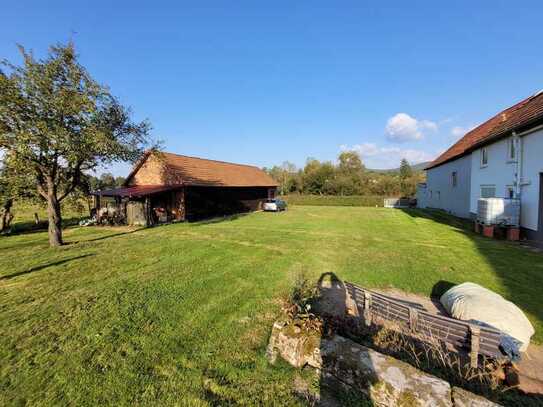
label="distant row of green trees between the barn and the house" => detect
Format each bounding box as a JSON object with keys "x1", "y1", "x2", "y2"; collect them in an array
[{"x1": 264, "y1": 151, "x2": 425, "y2": 197}]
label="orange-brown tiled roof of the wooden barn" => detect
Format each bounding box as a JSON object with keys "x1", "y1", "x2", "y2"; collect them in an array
[{"x1": 127, "y1": 152, "x2": 277, "y2": 187}]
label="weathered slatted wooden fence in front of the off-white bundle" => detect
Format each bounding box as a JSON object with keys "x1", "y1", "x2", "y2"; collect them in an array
[{"x1": 345, "y1": 282, "x2": 505, "y2": 367}]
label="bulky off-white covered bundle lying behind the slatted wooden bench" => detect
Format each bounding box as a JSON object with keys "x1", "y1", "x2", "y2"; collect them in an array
[{"x1": 440, "y1": 283, "x2": 535, "y2": 352}]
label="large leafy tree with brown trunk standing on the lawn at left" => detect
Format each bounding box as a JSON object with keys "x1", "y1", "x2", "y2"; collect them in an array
[{"x1": 0, "y1": 43, "x2": 150, "y2": 245}]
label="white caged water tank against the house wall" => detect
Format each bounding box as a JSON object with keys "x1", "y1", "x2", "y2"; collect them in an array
[{"x1": 477, "y1": 198, "x2": 520, "y2": 227}]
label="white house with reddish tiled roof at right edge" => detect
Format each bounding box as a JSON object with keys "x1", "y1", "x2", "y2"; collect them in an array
[{"x1": 417, "y1": 92, "x2": 543, "y2": 241}]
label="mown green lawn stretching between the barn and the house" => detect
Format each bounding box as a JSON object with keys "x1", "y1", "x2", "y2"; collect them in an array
[{"x1": 0, "y1": 206, "x2": 543, "y2": 405}]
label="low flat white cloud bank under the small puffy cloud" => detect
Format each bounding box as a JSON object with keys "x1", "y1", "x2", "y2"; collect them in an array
[{"x1": 340, "y1": 143, "x2": 436, "y2": 169}]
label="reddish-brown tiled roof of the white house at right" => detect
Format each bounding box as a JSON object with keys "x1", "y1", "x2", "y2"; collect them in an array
[{"x1": 425, "y1": 92, "x2": 543, "y2": 170}]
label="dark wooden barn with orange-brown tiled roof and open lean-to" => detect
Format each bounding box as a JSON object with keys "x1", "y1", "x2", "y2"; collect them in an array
[{"x1": 93, "y1": 151, "x2": 277, "y2": 226}]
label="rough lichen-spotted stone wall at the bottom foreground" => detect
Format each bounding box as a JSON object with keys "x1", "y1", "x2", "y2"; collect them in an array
[{"x1": 267, "y1": 322, "x2": 497, "y2": 407}]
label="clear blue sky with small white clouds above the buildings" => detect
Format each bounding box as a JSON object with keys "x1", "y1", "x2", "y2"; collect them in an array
[{"x1": 4, "y1": 0, "x2": 543, "y2": 175}]
